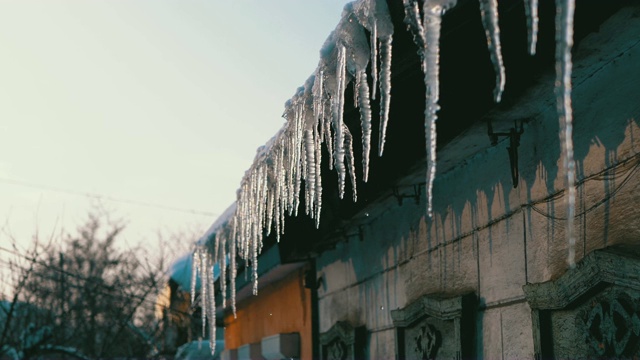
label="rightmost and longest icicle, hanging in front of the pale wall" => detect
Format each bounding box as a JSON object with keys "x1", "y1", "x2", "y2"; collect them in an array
[{"x1": 555, "y1": 0, "x2": 576, "y2": 267}]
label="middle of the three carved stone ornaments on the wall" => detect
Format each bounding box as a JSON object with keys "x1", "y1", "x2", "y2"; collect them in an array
[{"x1": 391, "y1": 294, "x2": 476, "y2": 359}]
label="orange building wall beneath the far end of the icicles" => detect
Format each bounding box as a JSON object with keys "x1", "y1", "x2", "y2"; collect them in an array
[{"x1": 224, "y1": 269, "x2": 312, "y2": 359}]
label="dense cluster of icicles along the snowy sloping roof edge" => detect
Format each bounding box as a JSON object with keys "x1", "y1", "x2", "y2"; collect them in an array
[{"x1": 230, "y1": 0, "x2": 393, "y2": 294}]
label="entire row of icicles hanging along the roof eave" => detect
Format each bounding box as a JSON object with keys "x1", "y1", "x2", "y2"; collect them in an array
[{"x1": 192, "y1": 0, "x2": 575, "y2": 352}]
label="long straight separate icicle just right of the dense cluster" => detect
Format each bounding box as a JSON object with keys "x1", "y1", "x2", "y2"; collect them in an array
[{"x1": 422, "y1": 2, "x2": 444, "y2": 217}]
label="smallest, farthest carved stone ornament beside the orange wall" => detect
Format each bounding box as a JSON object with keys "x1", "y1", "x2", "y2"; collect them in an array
[{"x1": 320, "y1": 321, "x2": 364, "y2": 360}]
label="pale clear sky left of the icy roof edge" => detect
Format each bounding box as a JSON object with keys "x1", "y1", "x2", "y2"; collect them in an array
[{"x1": 0, "y1": 0, "x2": 346, "y2": 262}]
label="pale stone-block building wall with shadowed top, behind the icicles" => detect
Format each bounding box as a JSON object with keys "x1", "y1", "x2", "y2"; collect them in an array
[{"x1": 317, "y1": 7, "x2": 640, "y2": 359}]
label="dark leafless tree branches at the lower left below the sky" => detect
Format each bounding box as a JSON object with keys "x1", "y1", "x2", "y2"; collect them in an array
[{"x1": 0, "y1": 212, "x2": 171, "y2": 359}]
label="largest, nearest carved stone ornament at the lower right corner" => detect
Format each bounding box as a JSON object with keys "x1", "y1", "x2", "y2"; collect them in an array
[{"x1": 523, "y1": 249, "x2": 640, "y2": 358}]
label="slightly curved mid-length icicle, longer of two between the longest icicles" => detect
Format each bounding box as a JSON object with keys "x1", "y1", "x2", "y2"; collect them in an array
[{"x1": 480, "y1": 0, "x2": 505, "y2": 103}]
